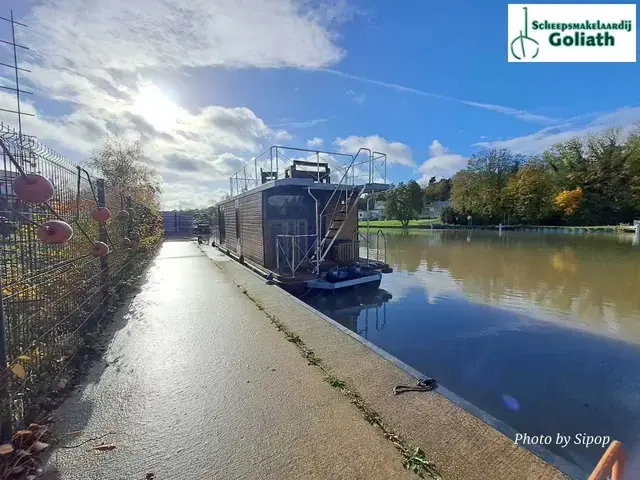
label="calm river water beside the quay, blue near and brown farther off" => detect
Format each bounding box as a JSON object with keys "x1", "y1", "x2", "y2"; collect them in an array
[{"x1": 310, "y1": 231, "x2": 640, "y2": 471}]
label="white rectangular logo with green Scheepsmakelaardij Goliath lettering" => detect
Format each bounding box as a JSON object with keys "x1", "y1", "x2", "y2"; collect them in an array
[{"x1": 507, "y1": 4, "x2": 637, "y2": 62}]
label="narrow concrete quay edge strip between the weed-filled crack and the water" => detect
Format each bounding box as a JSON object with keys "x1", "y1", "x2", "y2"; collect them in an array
[{"x1": 203, "y1": 246, "x2": 586, "y2": 480}]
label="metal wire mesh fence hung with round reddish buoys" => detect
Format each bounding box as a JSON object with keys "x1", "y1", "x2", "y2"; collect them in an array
[{"x1": 0, "y1": 125, "x2": 160, "y2": 437}]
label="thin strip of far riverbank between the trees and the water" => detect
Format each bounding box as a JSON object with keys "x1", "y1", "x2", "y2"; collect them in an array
[{"x1": 358, "y1": 220, "x2": 635, "y2": 233}]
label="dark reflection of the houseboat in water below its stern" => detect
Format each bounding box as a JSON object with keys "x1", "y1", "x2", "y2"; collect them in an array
[{"x1": 306, "y1": 289, "x2": 392, "y2": 338}]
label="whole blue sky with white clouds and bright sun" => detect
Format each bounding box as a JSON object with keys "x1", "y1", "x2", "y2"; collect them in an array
[{"x1": 0, "y1": 0, "x2": 640, "y2": 209}]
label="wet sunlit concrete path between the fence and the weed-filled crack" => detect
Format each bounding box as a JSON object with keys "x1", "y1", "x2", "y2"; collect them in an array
[{"x1": 47, "y1": 242, "x2": 417, "y2": 480}]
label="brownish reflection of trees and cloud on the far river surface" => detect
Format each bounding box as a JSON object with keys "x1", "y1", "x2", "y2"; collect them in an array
[{"x1": 374, "y1": 231, "x2": 640, "y2": 344}]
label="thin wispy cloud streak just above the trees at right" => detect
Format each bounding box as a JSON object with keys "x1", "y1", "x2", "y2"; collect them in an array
[{"x1": 474, "y1": 107, "x2": 640, "y2": 155}]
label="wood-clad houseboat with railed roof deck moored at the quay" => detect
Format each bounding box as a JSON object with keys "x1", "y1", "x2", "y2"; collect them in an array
[{"x1": 211, "y1": 146, "x2": 391, "y2": 294}]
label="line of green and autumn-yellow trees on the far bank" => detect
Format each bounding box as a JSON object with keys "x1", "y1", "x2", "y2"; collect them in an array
[{"x1": 381, "y1": 126, "x2": 640, "y2": 225}]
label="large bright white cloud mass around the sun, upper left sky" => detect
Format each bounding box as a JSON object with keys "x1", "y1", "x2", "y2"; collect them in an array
[{"x1": 0, "y1": 0, "x2": 354, "y2": 206}]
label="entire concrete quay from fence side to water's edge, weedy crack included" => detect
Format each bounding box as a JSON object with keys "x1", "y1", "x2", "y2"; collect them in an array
[{"x1": 42, "y1": 242, "x2": 579, "y2": 480}]
